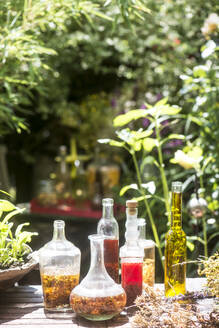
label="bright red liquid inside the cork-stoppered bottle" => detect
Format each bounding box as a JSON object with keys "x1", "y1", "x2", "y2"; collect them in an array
[{"x1": 121, "y1": 262, "x2": 142, "y2": 306}]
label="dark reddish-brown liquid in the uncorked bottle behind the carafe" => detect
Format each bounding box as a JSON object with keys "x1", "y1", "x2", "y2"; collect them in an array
[{"x1": 104, "y1": 239, "x2": 119, "y2": 283}]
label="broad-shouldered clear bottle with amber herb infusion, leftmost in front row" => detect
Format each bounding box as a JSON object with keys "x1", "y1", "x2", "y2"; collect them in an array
[{"x1": 39, "y1": 220, "x2": 81, "y2": 312}]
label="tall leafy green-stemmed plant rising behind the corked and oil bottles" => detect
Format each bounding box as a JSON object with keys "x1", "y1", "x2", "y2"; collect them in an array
[{"x1": 99, "y1": 98, "x2": 185, "y2": 263}]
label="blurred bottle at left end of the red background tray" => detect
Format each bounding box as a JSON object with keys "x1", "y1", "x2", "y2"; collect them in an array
[{"x1": 55, "y1": 145, "x2": 72, "y2": 199}]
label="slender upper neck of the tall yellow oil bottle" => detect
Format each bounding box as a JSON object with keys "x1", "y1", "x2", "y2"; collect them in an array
[{"x1": 171, "y1": 192, "x2": 182, "y2": 229}]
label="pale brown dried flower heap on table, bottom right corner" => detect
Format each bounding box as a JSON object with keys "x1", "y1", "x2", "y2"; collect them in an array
[{"x1": 132, "y1": 286, "x2": 219, "y2": 328}]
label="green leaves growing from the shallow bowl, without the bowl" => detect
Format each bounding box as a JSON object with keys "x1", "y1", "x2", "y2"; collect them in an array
[{"x1": 0, "y1": 199, "x2": 37, "y2": 269}]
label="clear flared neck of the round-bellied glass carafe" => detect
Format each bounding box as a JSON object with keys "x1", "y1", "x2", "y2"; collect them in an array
[{"x1": 89, "y1": 235, "x2": 105, "y2": 274}]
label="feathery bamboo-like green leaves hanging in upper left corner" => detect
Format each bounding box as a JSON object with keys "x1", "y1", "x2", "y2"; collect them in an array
[{"x1": 0, "y1": 0, "x2": 147, "y2": 135}]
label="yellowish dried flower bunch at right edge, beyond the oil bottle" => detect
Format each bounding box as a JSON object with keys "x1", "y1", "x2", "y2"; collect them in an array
[{"x1": 198, "y1": 252, "x2": 219, "y2": 297}]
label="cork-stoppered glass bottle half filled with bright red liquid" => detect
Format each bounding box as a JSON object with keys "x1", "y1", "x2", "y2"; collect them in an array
[{"x1": 120, "y1": 200, "x2": 144, "y2": 306}]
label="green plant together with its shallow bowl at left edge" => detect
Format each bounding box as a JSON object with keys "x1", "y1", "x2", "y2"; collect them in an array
[{"x1": 0, "y1": 199, "x2": 38, "y2": 289}]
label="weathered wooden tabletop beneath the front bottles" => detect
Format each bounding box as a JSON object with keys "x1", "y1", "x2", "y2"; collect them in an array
[{"x1": 0, "y1": 278, "x2": 211, "y2": 328}]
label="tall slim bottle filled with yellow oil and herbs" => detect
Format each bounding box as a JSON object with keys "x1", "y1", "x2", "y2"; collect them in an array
[{"x1": 164, "y1": 181, "x2": 186, "y2": 297}]
